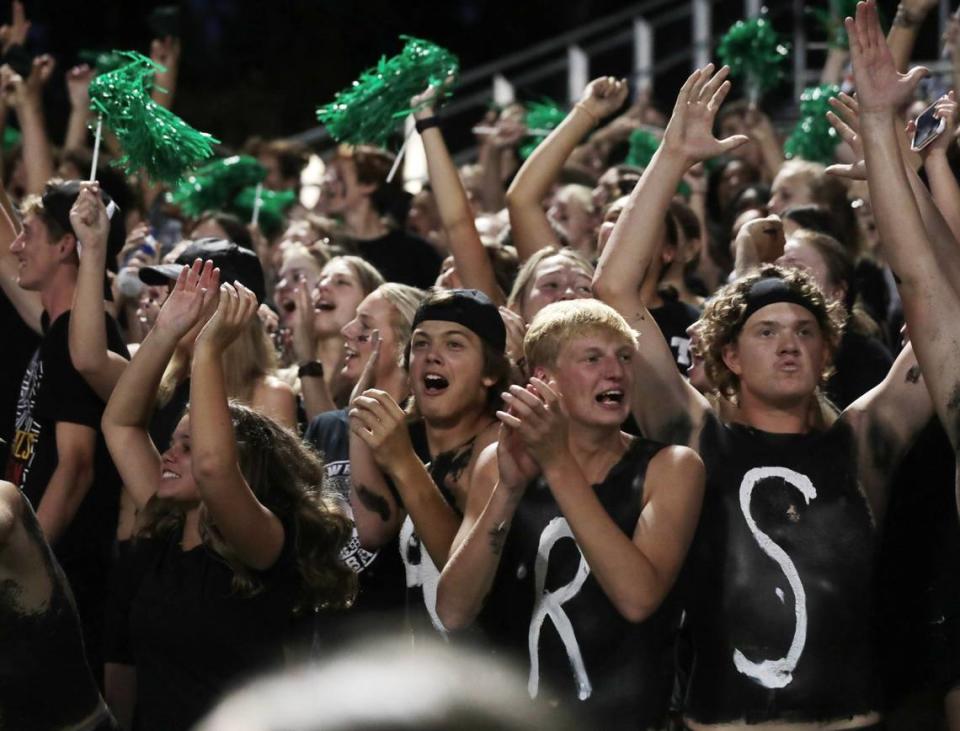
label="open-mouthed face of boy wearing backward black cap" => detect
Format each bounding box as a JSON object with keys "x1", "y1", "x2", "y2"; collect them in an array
[{"x1": 409, "y1": 320, "x2": 494, "y2": 424}]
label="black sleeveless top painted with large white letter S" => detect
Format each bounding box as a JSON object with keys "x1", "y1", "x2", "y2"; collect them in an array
[{"x1": 684, "y1": 416, "x2": 879, "y2": 723}]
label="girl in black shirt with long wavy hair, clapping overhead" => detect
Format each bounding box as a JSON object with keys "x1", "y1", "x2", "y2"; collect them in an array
[{"x1": 104, "y1": 262, "x2": 356, "y2": 729}]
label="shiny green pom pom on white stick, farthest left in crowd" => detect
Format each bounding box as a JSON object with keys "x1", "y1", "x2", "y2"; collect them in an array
[{"x1": 90, "y1": 51, "x2": 218, "y2": 184}]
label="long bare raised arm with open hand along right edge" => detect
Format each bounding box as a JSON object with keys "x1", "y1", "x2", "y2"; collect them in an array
[{"x1": 846, "y1": 1, "x2": 960, "y2": 448}]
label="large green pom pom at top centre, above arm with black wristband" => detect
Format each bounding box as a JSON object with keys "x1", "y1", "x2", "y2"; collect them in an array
[{"x1": 317, "y1": 36, "x2": 460, "y2": 147}]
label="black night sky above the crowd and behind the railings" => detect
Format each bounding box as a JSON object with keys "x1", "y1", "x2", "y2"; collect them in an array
[{"x1": 7, "y1": 0, "x2": 935, "y2": 152}]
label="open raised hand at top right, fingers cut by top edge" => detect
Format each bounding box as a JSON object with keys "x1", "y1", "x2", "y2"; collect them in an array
[{"x1": 844, "y1": 0, "x2": 929, "y2": 113}]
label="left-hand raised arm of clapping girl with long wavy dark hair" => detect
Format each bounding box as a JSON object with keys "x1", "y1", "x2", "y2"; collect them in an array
[{"x1": 102, "y1": 259, "x2": 219, "y2": 508}]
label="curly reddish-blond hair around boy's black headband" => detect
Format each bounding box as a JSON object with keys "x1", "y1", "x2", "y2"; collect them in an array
[{"x1": 698, "y1": 265, "x2": 847, "y2": 402}]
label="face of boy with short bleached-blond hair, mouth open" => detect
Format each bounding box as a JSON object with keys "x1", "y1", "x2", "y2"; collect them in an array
[{"x1": 537, "y1": 328, "x2": 635, "y2": 431}]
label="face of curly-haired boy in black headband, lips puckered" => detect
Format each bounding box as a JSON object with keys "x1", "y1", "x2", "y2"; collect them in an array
[{"x1": 723, "y1": 302, "x2": 830, "y2": 408}]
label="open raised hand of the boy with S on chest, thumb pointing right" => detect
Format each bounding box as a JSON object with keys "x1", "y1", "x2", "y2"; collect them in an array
[{"x1": 663, "y1": 64, "x2": 750, "y2": 167}]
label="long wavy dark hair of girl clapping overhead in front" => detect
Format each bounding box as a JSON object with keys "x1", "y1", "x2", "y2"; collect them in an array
[{"x1": 139, "y1": 402, "x2": 357, "y2": 611}]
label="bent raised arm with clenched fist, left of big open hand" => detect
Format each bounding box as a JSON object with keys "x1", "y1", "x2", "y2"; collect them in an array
[{"x1": 507, "y1": 76, "x2": 629, "y2": 262}]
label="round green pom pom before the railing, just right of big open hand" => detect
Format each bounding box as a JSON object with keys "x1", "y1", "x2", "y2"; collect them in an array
[{"x1": 717, "y1": 18, "x2": 788, "y2": 101}]
